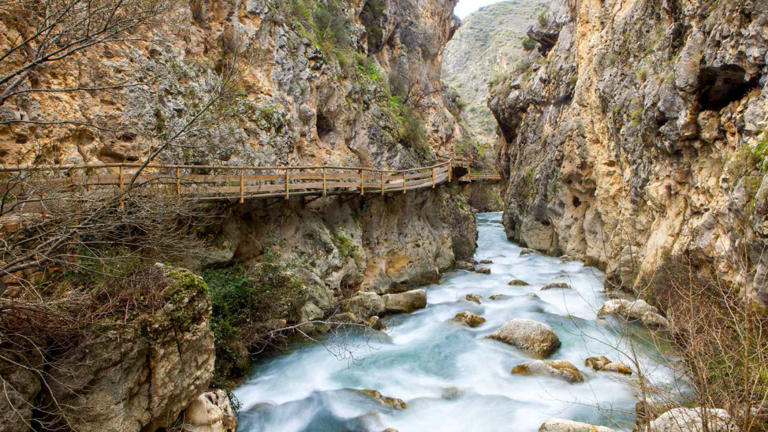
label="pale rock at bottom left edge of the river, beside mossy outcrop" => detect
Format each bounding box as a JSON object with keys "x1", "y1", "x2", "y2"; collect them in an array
[{"x1": 182, "y1": 390, "x2": 237, "y2": 432}]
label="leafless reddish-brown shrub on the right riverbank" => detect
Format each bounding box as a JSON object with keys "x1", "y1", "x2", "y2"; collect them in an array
[{"x1": 628, "y1": 258, "x2": 768, "y2": 432}]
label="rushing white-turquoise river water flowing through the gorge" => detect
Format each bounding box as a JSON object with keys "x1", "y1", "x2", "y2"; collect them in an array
[{"x1": 235, "y1": 213, "x2": 673, "y2": 432}]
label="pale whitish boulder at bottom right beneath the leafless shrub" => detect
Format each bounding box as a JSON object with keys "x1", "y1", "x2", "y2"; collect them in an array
[{"x1": 651, "y1": 408, "x2": 740, "y2": 432}]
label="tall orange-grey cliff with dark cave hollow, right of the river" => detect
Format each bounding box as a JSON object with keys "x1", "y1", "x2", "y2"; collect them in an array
[{"x1": 489, "y1": 0, "x2": 768, "y2": 304}]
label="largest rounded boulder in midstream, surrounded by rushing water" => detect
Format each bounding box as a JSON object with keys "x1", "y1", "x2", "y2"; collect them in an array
[{"x1": 488, "y1": 318, "x2": 560, "y2": 358}]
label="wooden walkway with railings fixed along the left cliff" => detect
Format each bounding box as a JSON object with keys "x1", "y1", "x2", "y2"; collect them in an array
[{"x1": 0, "y1": 158, "x2": 500, "y2": 207}]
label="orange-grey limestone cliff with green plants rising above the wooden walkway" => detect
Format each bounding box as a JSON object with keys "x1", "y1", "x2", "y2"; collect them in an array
[{"x1": 0, "y1": 0, "x2": 458, "y2": 168}]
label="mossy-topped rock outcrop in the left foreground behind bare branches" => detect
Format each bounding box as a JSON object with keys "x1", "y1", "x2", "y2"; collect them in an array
[{"x1": 0, "y1": 269, "x2": 216, "y2": 432}]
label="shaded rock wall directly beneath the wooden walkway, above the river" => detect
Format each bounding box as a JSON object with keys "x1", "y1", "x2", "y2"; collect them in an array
[{"x1": 215, "y1": 188, "x2": 477, "y2": 328}]
